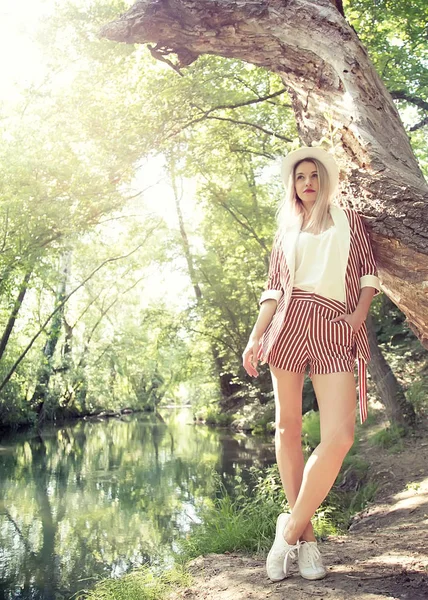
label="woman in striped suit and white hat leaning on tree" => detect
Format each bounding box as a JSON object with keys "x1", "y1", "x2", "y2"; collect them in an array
[{"x1": 243, "y1": 148, "x2": 380, "y2": 581}]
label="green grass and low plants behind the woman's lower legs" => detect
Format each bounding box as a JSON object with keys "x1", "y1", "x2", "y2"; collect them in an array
[{"x1": 178, "y1": 455, "x2": 377, "y2": 562}]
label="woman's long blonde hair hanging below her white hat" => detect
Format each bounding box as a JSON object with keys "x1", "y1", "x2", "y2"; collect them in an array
[{"x1": 276, "y1": 158, "x2": 333, "y2": 238}]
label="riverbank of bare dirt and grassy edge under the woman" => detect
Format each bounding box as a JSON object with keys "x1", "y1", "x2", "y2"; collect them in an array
[{"x1": 83, "y1": 422, "x2": 428, "y2": 600}]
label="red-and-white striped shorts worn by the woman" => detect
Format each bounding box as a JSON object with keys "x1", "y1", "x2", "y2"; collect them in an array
[{"x1": 267, "y1": 288, "x2": 357, "y2": 377}]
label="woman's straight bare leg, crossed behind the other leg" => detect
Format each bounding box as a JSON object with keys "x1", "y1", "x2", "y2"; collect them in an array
[{"x1": 270, "y1": 365, "x2": 315, "y2": 542}]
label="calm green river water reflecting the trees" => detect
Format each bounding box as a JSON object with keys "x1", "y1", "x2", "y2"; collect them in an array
[{"x1": 0, "y1": 409, "x2": 274, "y2": 600}]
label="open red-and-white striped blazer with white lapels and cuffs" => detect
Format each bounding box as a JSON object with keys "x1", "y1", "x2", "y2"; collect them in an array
[{"x1": 258, "y1": 204, "x2": 380, "y2": 423}]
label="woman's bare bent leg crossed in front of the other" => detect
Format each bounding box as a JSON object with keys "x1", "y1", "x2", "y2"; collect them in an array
[{"x1": 284, "y1": 372, "x2": 356, "y2": 544}]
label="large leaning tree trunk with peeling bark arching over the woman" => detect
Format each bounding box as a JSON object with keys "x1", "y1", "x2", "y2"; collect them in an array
[{"x1": 101, "y1": 0, "x2": 428, "y2": 348}]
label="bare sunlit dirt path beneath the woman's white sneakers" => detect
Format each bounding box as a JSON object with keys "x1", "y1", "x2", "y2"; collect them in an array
[{"x1": 171, "y1": 422, "x2": 428, "y2": 600}]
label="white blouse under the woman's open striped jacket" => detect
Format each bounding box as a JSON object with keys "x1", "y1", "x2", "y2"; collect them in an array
[{"x1": 293, "y1": 226, "x2": 345, "y2": 302}]
